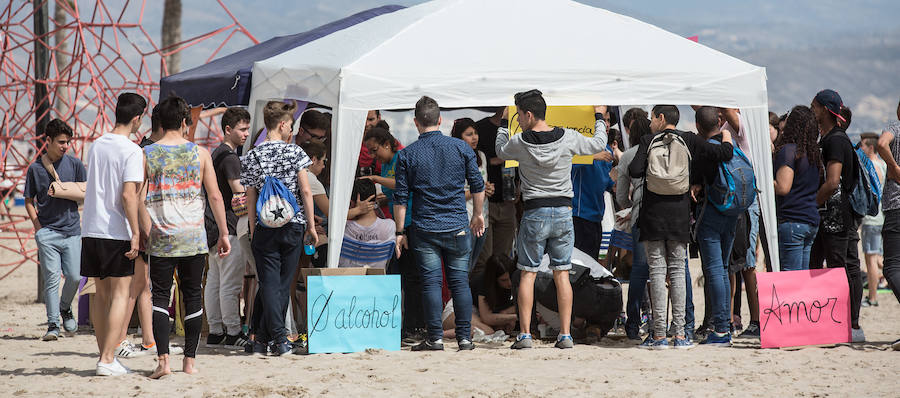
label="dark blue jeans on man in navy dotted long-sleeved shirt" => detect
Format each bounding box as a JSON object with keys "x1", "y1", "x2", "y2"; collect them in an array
[{"x1": 410, "y1": 227, "x2": 472, "y2": 341}]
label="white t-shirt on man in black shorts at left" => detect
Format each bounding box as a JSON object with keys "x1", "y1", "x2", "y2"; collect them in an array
[{"x1": 81, "y1": 133, "x2": 144, "y2": 240}]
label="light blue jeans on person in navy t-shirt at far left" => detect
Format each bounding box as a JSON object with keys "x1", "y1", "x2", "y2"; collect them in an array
[{"x1": 34, "y1": 228, "x2": 81, "y2": 326}]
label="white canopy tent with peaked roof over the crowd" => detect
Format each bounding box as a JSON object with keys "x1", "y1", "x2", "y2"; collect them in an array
[{"x1": 250, "y1": 0, "x2": 778, "y2": 269}]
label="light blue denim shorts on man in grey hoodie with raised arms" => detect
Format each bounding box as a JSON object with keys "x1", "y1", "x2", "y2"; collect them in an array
[{"x1": 516, "y1": 206, "x2": 575, "y2": 272}]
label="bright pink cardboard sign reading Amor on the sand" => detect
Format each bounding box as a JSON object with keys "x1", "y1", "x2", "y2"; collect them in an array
[{"x1": 756, "y1": 268, "x2": 850, "y2": 348}]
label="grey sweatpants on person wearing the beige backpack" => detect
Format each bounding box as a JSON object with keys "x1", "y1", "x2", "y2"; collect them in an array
[{"x1": 644, "y1": 240, "x2": 687, "y2": 338}]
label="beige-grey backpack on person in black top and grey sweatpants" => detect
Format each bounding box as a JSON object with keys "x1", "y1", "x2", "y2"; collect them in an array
[{"x1": 646, "y1": 130, "x2": 691, "y2": 195}]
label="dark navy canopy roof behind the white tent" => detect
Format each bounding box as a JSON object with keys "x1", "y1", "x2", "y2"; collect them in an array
[{"x1": 159, "y1": 5, "x2": 405, "y2": 108}]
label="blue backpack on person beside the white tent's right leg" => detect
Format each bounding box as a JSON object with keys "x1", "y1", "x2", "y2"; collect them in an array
[{"x1": 706, "y1": 139, "x2": 757, "y2": 216}]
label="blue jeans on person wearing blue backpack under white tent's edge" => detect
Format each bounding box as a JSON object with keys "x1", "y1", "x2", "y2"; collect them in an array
[{"x1": 697, "y1": 205, "x2": 750, "y2": 333}]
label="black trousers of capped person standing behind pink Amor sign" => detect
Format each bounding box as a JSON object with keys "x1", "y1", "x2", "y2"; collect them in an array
[{"x1": 809, "y1": 217, "x2": 864, "y2": 329}]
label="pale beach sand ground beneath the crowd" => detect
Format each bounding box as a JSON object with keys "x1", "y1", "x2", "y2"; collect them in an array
[{"x1": 0, "y1": 216, "x2": 900, "y2": 397}]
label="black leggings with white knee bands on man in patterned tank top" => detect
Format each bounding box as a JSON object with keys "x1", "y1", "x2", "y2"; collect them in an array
[{"x1": 150, "y1": 254, "x2": 206, "y2": 358}]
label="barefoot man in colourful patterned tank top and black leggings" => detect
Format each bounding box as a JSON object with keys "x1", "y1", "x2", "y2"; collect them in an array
[{"x1": 141, "y1": 97, "x2": 231, "y2": 379}]
